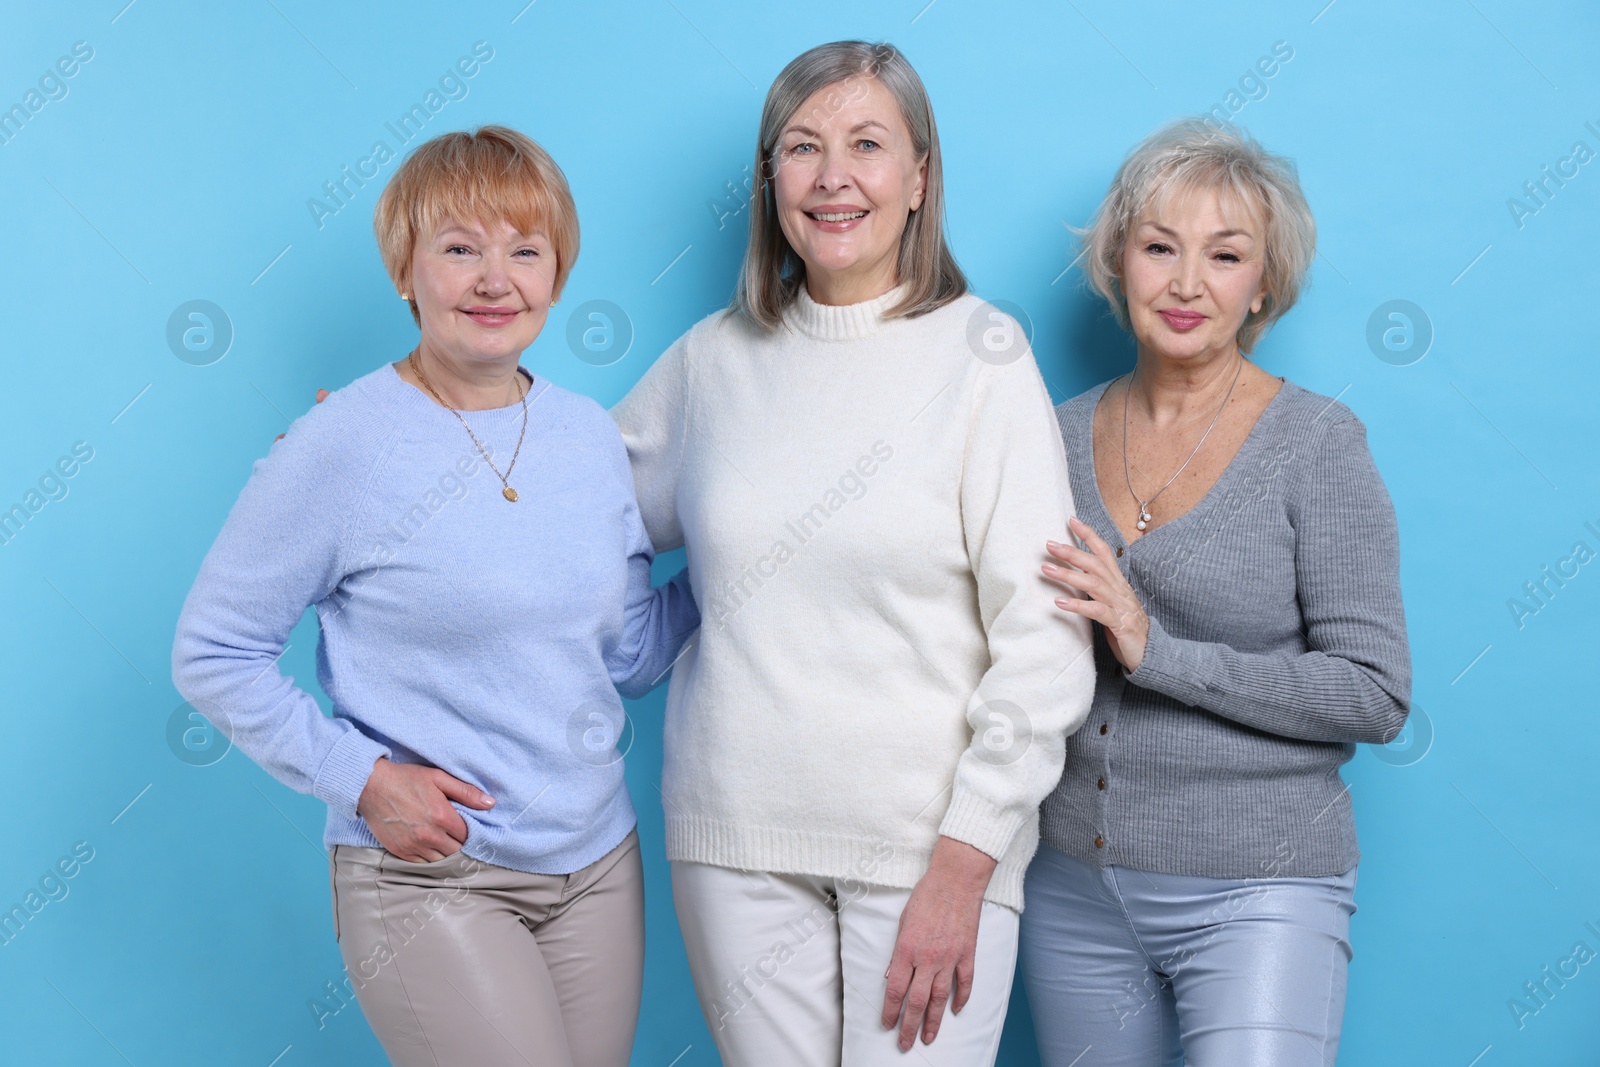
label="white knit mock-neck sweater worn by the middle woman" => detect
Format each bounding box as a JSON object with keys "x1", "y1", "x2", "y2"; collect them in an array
[{"x1": 613, "y1": 288, "x2": 1094, "y2": 909}]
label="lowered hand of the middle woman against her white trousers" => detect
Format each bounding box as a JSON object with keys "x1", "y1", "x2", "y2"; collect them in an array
[{"x1": 882, "y1": 837, "x2": 995, "y2": 1053}]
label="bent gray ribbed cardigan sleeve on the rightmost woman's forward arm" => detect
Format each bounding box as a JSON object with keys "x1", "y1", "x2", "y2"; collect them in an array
[{"x1": 1128, "y1": 414, "x2": 1411, "y2": 744}]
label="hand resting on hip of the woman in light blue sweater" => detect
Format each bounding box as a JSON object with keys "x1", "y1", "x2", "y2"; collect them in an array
[{"x1": 355, "y1": 757, "x2": 494, "y2": 864}]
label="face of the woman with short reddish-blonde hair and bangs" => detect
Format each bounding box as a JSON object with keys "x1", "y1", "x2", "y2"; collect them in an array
[{"x1": 411, "y1": 221, "x2": 555, "y2": 373}]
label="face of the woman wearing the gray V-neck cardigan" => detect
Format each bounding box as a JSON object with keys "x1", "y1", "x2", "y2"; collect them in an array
[{"x1": 1120, "y1": 189, "x2": 1267, "y2": 362}]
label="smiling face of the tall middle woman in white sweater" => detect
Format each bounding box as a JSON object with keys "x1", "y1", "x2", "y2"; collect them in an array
[{"x1": 773, "y1": 77, "x2": 928, "y2": 304}]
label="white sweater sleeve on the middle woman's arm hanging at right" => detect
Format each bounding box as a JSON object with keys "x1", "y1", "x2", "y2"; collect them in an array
[{"x1": 939, "y1": 354, "x2": 1094, "y2": 859}]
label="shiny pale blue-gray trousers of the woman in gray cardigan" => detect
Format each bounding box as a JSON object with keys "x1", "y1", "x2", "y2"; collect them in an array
[{"x1": 1022, "y1": 846, "x2": 1355, "y2": 1067}]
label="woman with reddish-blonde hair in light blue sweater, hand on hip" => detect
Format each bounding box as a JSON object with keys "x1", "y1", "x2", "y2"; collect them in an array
[{"x1": 173, "y1": 126, "x2": 699, "y2": 1067}]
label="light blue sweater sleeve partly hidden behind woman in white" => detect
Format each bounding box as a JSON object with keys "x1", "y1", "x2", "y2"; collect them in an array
[{"x1": 606, "y1": 425, "x2": 699, "y2": 699}]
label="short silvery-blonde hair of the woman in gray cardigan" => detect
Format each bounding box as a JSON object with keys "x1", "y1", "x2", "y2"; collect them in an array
[{"x1": 1078, "y1": 118, "x2": 1317, "y2": 352}]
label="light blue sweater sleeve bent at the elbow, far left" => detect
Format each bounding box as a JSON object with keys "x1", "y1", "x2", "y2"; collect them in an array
[{"x1": 173, "y1": 403, "x2": 389, "y2": 819}]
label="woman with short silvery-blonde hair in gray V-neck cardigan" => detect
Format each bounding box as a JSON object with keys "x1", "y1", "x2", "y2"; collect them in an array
[{"x1": 1022, "y1": 120, "x2": 1411, "y2": 1067}]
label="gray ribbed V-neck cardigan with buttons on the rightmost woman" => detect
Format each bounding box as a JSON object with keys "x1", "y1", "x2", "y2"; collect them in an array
[{"x1": 1040, "y1": 382, "x2": 1411, "y2": 878}]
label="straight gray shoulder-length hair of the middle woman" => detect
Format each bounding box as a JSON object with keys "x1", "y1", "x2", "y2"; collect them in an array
[{"x1": 730, "y1": 40, "x2": 966, "y2": 330}]
